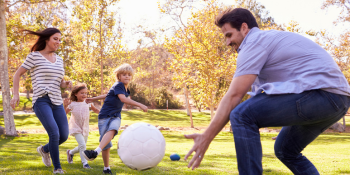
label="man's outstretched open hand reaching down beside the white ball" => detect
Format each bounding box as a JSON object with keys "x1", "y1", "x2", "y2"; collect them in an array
[{"x1": 185, "y1": 134, "x2": 211, "y2": 170}]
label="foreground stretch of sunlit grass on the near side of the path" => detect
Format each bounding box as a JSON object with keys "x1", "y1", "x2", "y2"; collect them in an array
[{"x1": 0, "y1": 131, "x2": 350, "y2": 175}]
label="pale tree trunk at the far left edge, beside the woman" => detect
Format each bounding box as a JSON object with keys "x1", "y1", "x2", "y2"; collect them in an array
[{"x1": 0, "y1": 0, "x2": 17, "y2": 136}]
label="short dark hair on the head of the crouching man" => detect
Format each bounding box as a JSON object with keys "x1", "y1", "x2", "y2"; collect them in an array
[{"x1": 215, "y1": 8, "x2": 259, "y2": 31}]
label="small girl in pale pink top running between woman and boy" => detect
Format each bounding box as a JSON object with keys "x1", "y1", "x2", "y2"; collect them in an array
[{"x1": 64, "y1": 83, "x2": 100, "y2": 169}]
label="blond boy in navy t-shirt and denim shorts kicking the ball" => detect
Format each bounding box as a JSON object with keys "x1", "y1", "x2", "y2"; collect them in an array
[{"x1": 83, "y1": 64, "x2": 148, "y2": 174}]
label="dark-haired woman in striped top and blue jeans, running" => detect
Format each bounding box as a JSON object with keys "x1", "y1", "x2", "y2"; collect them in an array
[{"x1": 10, "y1": 28, "x2": 72, "y2": 174}]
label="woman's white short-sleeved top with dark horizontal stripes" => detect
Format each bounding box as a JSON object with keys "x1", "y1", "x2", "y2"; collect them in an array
[{"x1": 22, "y1": 51, "x2": 64, "y2": 105}]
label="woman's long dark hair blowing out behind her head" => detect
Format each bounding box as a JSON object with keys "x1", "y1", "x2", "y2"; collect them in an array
[{"x1": 23, "y1": 28, "x2": 61, "y2": 52}]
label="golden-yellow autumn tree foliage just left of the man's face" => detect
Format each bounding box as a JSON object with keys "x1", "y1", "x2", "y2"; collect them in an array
[{"x1": 161, "y1": 1, "x2": 236, "y2": 116}]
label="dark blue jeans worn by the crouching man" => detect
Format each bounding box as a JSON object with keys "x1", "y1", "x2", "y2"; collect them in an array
[{"x1": 230, "y1": 90, "x2": 350, "y2": 175}]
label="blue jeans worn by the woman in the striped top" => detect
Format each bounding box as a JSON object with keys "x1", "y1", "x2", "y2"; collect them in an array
[{"x1": 33, "y1": 95, "x2": 69, "y2": 170}]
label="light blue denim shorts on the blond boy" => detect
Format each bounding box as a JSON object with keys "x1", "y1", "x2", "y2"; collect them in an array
[{"x1": 98, "y1": 117, "x2": 120, "y2": 150}]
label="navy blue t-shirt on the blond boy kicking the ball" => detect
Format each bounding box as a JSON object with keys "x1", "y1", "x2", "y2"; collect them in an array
[{"x1": 98, "y1": 82, "x2": 130, "y2": 119}]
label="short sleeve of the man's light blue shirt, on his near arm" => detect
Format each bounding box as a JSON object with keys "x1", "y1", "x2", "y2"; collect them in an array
[{"x1": 234, "y1": 43, "x2": 268, "y2": 77}]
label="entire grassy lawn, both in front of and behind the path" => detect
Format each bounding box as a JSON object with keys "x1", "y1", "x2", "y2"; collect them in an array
[{"x1": 0, "y1": 110, "x2": 350, "y2": 175}]
